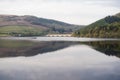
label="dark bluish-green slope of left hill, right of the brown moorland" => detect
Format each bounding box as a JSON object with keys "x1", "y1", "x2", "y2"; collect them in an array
[{"x1": 25, "y1": 16, "x2": 83, "y2": 33}]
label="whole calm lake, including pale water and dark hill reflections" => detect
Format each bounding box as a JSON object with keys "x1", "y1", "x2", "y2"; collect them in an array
[{"x1": 0, "y1": 37, "x2": 120, "y2": 80}]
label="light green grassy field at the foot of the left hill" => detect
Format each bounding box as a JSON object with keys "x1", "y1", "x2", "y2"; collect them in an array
[{"x1": 0, "y1": 26, "x2": 47, "y2": 36}]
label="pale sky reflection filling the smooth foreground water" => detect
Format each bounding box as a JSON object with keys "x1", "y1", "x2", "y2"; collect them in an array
[{"x1": 0, "y1": 45, "x2": 120, "y2": 80}]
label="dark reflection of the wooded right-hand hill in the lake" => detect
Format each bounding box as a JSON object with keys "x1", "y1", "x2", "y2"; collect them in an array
[{"x1": 85, "y1": 41, "x2": 120, "y2": 58}]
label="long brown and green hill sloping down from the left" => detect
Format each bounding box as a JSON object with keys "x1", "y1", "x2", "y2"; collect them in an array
[{"x1": 0, "y1": 15, "x2": 83, "y2": 36}]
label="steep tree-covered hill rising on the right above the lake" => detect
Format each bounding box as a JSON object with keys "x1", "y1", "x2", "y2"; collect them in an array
[{"x1": 73, "y1": 13, "x2": 120, "y2": 38}]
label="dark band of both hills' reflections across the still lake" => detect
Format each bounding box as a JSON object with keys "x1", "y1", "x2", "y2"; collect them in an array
[{"x1": 0, "y1": 40, "x2": 120, "y2": 58}]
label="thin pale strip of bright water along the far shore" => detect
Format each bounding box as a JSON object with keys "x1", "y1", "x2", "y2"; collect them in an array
[{"x1": 0, "y1": 36, "x2": 120, "y2": 42}]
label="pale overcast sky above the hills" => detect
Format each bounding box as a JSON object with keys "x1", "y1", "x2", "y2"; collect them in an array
[{"x1": 0, "y1": 0, "x2": 120, "y2": 25}]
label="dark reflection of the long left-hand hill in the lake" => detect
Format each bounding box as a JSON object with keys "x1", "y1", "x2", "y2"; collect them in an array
[{"x1": 0, "y1": 40, "x2": 77, "y2": 57}]
